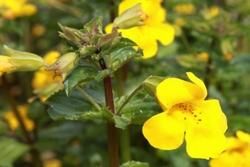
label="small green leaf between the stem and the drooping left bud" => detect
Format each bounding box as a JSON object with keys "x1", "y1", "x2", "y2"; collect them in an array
[{"x1": 64, "y1": 66, "x2": 97, "y2": 95}]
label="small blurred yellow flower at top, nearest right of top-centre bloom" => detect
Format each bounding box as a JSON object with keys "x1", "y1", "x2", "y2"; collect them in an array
[{"x1": 174, "y1": 3, "x2": 196, "y2": 15}]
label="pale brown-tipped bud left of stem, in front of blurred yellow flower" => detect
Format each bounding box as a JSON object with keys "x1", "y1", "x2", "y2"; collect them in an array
[{"x1": 47, "y1": 52, "x2": 77, "y2": 78}]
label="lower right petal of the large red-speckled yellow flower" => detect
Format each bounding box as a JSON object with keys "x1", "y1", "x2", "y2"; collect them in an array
[{"x1": 185, "y1": 100, "x2": 227, "y2": 159}]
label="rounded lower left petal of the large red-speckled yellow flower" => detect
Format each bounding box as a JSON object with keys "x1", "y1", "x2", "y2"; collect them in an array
[{"x1": 142, "y1": 112, "x2": 185, "y2": 150}]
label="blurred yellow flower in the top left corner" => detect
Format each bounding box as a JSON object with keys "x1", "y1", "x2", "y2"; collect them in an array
[{"x1": 0, "y1": 0, "x2": 37, "y2": 19}]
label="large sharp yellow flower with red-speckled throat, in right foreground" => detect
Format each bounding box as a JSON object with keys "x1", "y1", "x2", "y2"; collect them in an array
[{"x1": 142, "y1": 72, "x2": 227, "y2": 159}]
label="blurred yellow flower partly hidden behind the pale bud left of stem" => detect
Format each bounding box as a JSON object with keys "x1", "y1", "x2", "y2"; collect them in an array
[{"x1": 32, "y1": 51, "x2": 63, "y2": 101}]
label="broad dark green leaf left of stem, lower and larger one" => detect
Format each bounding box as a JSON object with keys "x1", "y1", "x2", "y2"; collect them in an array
[{"x1": 48, "y1": 91, "x2": 110, "y2": 120}]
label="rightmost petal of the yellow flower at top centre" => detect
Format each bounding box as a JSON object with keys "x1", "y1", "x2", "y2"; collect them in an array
[{"x1": 148, "y1": 24, "x2": 175, "y2": 45}]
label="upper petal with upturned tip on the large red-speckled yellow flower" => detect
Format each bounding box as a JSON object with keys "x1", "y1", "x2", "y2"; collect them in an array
[{"x1": 156, "y1": 73, "x2": 206, "y2": 110}]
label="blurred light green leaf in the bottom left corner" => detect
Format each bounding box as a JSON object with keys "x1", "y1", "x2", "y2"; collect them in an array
[{"x1": 0, "y1": 137, "x2": 29, "y2": 167}]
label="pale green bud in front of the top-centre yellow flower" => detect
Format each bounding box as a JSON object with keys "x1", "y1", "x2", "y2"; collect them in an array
[{"x1": 114, "y1": 3, "x2": 147, "y2": 29}]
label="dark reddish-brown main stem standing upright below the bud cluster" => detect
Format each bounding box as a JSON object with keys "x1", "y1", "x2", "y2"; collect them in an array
[{"x1": 99, "y1": 59, "x2": 119, "y2": 167}]
